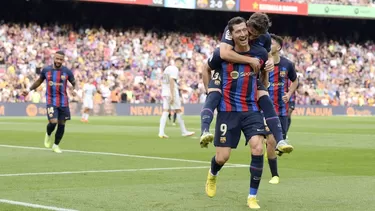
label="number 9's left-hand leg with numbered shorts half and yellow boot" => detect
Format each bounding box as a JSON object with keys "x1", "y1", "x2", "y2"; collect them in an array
[{"x1": 206, "y1": 112, "x2": 241, "y2": 197}]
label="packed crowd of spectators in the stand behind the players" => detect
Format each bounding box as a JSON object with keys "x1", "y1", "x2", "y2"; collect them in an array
[{"x1": 0, "y1": 24, "x2": 375, "y2": 106}]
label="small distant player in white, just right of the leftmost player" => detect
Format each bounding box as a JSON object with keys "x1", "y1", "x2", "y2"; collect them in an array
[{"x1": 81, "y1": 79, "x2": 97, "y2": 122}]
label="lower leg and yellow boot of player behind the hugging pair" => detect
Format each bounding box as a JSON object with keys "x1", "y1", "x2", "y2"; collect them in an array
[{"x1": 267, "y1": 134, "x2": 280, "y2": 184}]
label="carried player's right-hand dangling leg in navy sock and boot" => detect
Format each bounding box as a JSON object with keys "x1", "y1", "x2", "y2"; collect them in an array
[{"x1": 258, "y1": 90, "x2": 293, "y2": 153}]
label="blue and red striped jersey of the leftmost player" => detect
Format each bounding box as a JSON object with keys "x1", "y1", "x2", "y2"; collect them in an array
[{"x1": 41, "y1": 65, "x2": 74, "y2": 107}]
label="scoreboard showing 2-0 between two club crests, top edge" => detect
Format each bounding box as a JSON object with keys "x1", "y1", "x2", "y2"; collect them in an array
[{"x1": 196, "y1": 0, "x2": 239, "y2": 11}]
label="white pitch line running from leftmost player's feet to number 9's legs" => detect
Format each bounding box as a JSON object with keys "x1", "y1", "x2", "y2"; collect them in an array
[{"x1": 0, "y1": 144, "x2": 248, "y2": 167}]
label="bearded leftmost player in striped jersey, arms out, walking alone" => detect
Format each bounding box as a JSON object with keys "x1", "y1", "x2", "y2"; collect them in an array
[{"x1": 23, "y1": 51, "x2": 76, "y2": 153}]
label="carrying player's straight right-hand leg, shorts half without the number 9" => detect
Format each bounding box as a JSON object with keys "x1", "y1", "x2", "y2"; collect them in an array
[{"x1": 241, "y1": 112, "x2": 266, "y2": 209}]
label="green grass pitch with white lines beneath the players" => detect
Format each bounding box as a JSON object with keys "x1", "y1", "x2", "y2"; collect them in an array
[{"x1": 0, "y1": 116, "x2": 375, "y2": 211}]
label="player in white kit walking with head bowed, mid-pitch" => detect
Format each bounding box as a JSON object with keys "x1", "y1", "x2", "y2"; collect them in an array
[{"x1": 159, "y1": 58, "x2": 195, "y2": 138}]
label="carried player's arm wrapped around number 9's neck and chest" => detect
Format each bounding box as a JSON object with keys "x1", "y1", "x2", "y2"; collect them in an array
[{"x1": 220, "y1": 27, "x2": 260, "y2": 71}]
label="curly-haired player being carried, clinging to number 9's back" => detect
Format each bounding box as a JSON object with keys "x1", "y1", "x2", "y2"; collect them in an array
[{"x1": 200, "y1": 13, "x2": 293, "y2": 153}]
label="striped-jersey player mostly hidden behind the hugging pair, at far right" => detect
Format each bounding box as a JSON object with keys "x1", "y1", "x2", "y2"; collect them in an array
[{"x1": 267, "y1": 34, "x2": 298, "y2": 184}]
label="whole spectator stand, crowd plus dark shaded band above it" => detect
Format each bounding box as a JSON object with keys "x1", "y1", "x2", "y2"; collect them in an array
[{"x1": 0, "y1": 1, "x2": 375, "y2": 106}]
